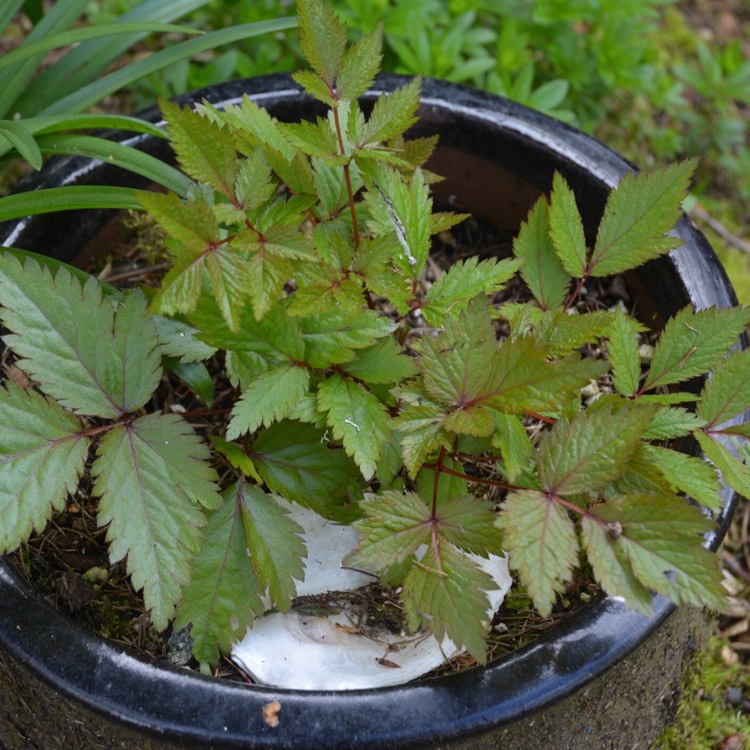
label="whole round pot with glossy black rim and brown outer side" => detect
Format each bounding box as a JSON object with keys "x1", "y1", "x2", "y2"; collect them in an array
[{"x1": 0, "y1": 75, "x2": 736, "y2": 750}]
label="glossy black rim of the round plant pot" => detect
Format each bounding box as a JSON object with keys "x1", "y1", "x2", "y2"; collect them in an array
[{"x1": 0, "y1": 74, "x2": 739, "y2": 750}]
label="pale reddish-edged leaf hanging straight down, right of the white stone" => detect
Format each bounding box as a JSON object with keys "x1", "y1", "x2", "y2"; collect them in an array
[{"x1": 496, "y1": 490, "x2": 578, "y2": 617}]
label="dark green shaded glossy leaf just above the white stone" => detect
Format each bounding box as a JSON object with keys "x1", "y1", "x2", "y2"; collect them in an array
[{"x1": 248, "y1": 421, "x2": 362, "y2": 523}]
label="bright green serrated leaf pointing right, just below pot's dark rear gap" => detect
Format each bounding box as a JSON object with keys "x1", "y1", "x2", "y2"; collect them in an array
[{"x1": 421, "y1": 256, "x2": 519, "y2": 328}]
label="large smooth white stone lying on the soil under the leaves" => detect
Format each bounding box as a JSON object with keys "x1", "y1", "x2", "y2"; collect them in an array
[{"x1": 232, "y1": 503, "x2": 511, "y2": 690}]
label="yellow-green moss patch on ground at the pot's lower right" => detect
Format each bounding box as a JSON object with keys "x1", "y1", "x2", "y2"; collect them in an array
[{"x1": 653, "y1": 637, "x2": 750, "y2": 750}]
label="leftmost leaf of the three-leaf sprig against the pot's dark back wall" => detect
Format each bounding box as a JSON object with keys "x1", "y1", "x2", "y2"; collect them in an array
[{"x1": 513, "y1": 195, "x2": 570, "y2": 310}]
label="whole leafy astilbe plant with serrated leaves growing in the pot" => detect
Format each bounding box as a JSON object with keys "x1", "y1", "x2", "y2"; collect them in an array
[{"x1": 0, "y1": 0, "x2": 750, "y2": 666}]
